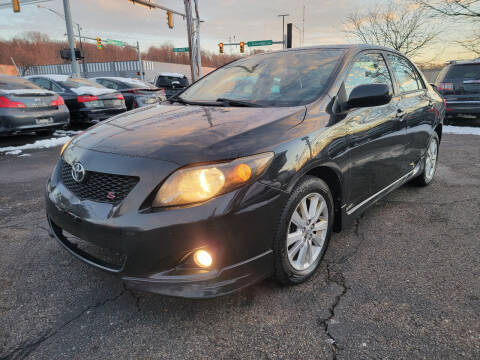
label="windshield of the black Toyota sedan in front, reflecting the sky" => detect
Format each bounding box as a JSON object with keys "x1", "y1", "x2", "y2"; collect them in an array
[{"x1": 181, "y1": 49, "x2": 345, "y2": 106}]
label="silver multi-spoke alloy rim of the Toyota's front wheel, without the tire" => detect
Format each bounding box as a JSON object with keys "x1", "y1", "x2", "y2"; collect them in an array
[{"x1": 286, "y1": 193, "x2": 328, "y2": 271}]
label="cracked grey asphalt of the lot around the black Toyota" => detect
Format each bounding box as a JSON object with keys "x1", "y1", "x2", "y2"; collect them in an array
[{"x1": 0, "y1": 135, "x2": 480, "y2": 360}]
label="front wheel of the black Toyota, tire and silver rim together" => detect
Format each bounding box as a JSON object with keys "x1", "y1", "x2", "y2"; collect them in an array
[{"x1": 274, "y1": 176, "x2": 334, "y2": 285}]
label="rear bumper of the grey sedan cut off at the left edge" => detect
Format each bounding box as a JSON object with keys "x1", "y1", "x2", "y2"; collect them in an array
[{"x1": 0, "y1": 106, "x2": 70, "y2": 134}]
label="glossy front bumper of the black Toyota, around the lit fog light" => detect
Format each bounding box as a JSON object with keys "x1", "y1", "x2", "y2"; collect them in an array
[{"x1": 46, "y1": 149, "x2": 287, "y2": 298}]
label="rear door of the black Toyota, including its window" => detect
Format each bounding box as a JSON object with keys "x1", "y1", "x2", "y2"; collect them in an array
[{"x1": 387, "y1": 53, "x2": 436, "y2": 169}]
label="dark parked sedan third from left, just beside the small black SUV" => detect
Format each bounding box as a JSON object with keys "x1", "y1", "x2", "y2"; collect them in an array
[{"x1": 90, "y1": 77, "x2": 166, "y2": 110}]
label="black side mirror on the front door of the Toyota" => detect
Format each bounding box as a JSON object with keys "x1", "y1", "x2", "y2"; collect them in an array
[{"x1": 347, "y1": 84, "x2": 392, "y2": 108}]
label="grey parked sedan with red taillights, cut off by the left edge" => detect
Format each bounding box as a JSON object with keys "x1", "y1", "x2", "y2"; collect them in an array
[{"x1": 0, "y1": 75, "x2": 70, "y2": 135}]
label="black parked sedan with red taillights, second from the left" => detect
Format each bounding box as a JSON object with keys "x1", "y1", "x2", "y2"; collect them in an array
[{"x1": 27, "y1": 75, "x2": 127, "y2": 122}]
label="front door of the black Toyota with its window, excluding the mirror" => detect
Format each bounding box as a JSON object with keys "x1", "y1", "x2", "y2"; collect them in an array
[{"x1": 344, "y1": 52, "x2": 406, "y2": 212}]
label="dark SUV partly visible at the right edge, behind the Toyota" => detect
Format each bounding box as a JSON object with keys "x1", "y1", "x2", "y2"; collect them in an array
[{"x1": 435, "y1": 59, "x2": 480, "y2": 117}]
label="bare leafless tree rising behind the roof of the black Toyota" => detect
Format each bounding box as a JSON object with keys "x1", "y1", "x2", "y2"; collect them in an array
[{"x1": 344, "y1": 0, "x2": 438, "y2": 55}]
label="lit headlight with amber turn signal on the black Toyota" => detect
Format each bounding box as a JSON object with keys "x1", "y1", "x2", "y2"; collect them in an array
[{"x1": 153, "y1": 153, "x2": 273, "y2": 207}]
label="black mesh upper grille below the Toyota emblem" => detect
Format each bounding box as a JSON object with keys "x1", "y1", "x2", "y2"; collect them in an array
[{"x1": 62, "y1": 160, "x2": 138, "y2": 205}]
